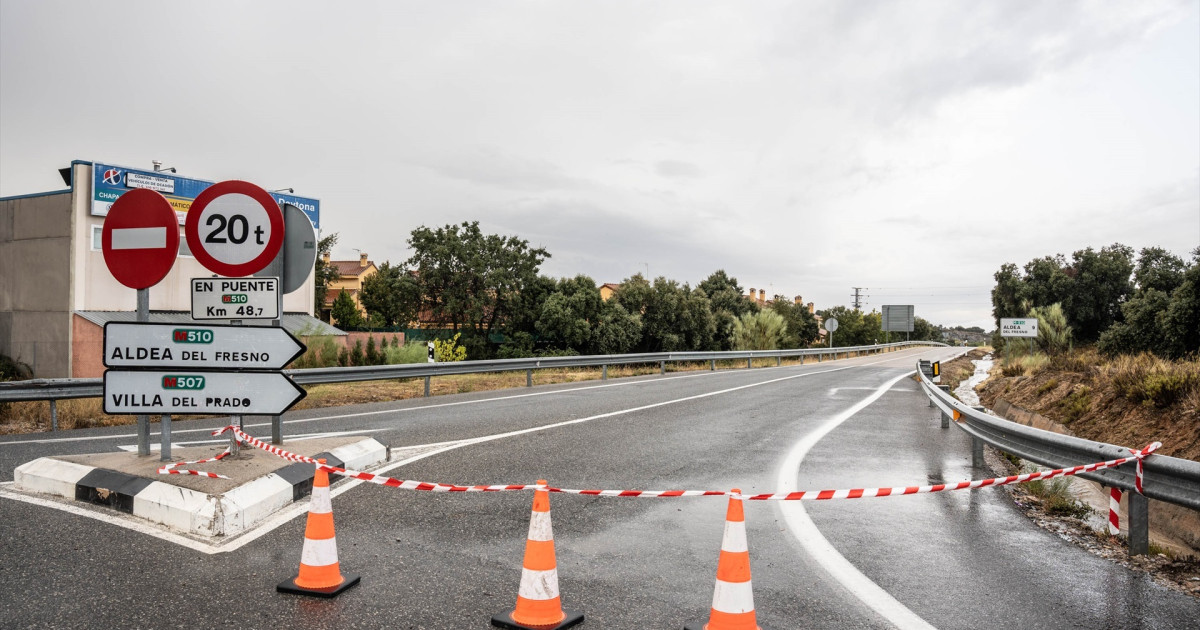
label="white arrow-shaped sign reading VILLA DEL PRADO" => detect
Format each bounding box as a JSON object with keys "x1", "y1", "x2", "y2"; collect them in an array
[{"x1": 104, "y1": 370, "x2": 307, "y2": 415}]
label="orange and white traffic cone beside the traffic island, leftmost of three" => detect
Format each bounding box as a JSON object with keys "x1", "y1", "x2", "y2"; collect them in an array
[{"x1": 275, "y1": 460, "x2": 359, "y2": 598}]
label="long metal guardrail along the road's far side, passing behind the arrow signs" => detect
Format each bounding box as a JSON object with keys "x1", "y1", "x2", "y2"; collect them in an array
[{"x1": 0, "y1": 341, "x2": 946, "y2": 402}]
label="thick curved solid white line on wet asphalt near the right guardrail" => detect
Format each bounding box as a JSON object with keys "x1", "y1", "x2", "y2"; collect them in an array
[{"x1": 775, "y1": 372, "x2": 934, "y2": 630}]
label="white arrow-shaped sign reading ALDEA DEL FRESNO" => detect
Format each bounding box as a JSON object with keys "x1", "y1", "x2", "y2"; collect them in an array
[{"x1": 104, "y1": 322, "x2": 305, "y2": 370}]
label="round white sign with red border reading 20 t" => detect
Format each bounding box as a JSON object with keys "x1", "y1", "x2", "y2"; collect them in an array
[{"x1": 184, "y1": 180, "x2": 283, "y2": 277}]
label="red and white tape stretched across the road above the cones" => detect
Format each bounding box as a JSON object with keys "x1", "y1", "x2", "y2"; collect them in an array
[{"x1": 204, "y1": 425, "x2": 1162, "y2": 500}]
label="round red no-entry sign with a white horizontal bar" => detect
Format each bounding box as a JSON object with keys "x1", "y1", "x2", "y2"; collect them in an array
[{"x1": 101, "y1": 188, "x2": 179, "y2": 289}]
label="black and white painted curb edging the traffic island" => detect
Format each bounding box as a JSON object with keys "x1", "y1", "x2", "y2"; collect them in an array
[{"x1": 13, "y1": 438, "x2": 388, "y2": 536}]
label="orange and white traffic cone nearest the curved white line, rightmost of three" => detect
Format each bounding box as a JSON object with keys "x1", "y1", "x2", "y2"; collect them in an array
[{"x1": 684, "y1": 488, "x2": 762, "y2": 630}]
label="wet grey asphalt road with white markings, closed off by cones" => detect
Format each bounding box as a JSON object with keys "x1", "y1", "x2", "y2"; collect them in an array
[{"x1": 0, "y1": 349, "x2": 1200, "y2": 630}]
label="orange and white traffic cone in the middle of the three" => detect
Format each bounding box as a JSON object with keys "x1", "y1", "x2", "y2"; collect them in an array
[{"x1": 492, "y1": 479, "x2": 583, "y2": 630}]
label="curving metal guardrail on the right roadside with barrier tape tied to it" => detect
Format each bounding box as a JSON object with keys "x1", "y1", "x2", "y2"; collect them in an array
[{"x1": 917, "y1": 366, "x2": 1200, "y2": 510}]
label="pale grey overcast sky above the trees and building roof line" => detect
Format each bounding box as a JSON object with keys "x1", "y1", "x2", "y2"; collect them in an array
[{"x1": 0, "y1": 0, "x2": 1200, "y2": 330}]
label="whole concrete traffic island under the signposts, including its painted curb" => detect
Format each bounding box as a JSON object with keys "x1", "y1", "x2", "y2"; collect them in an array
[{"x1": 13, "y1": 436, "x2": 388, "y2": 538}]
